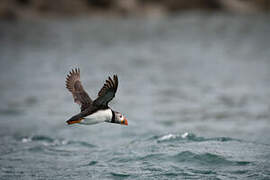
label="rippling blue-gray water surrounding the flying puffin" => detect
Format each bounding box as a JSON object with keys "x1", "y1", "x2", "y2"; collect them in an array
[{"x1": 0, "y1": 13, "x2": 270, "y2": 179}]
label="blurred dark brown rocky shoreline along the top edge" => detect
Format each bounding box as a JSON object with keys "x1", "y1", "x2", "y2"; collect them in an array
[{"x1": 0, "y1": 0, "x2": 270, "y2": 20}]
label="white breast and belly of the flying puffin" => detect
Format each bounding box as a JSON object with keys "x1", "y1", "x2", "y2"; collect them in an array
[{"x1": 81, "y1": 109, "x2": 112, "y2": 125}]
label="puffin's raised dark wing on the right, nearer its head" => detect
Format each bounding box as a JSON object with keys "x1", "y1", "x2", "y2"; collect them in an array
[{"x1": 94, "y1": 75, "x2": 118, "y2": 107}]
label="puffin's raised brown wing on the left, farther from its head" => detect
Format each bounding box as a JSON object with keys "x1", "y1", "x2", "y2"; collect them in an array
[{"x1": 66, "y1": 68, "x2": 92, "y2": 111}]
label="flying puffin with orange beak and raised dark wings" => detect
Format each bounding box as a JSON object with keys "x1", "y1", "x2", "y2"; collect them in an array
[{"x1": 66, "y1": 68, "x2": 128, "y2": 125}]
